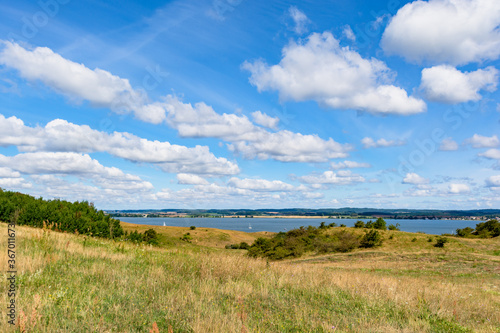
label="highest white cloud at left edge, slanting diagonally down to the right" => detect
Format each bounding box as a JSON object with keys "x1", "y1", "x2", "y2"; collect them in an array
[{"x1": 0, "y1": 41, "x2": 166, "y2": 124}]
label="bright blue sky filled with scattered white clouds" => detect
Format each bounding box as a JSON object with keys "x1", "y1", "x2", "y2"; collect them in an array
[{"x1": 0, "y1": 0, "x2": 500, "y2": 209}]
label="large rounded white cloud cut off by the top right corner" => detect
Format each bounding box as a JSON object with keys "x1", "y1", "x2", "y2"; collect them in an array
[{"x1": 381, "y1": 0, "x2": 500, "y2": 65}]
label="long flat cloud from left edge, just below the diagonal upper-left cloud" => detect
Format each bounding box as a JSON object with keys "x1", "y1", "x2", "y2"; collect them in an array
[{"x1": 0, "y1": 115, "x2": 239, "y2": 175}]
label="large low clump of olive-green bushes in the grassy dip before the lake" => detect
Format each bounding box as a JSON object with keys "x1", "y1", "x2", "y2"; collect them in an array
[{"x1": 249, "y1": 226, "x2": 360, "y2": 260}]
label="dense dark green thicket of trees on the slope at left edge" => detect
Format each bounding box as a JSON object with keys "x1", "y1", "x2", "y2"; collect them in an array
[{"x1": 0, "y1": 189, "x2": 123, "y2": 238}]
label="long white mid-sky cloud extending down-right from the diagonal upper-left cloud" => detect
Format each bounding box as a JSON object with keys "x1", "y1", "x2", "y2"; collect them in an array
[{"x1": 167, "y1": 97, "x2": 352, "y2": 162}]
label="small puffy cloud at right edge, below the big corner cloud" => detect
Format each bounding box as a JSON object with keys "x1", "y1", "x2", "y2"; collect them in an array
[{"x1": 420, "y1": 65, "x2": 498, "y2": 104}]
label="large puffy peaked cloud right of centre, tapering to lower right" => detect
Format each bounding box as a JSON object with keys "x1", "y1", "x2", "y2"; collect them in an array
[{"x1": 242, "y1": 32, "x2": 426, "y2": 115}]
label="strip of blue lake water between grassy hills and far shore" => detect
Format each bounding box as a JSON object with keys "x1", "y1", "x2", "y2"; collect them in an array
[{"x1": 119, "y1": 217, "x2": 479, "y2": 235}]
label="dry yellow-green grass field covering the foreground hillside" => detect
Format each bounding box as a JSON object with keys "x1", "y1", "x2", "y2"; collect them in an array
[{"x1": 0, "y1": 223, "x2": 500, "y2": 332}]
